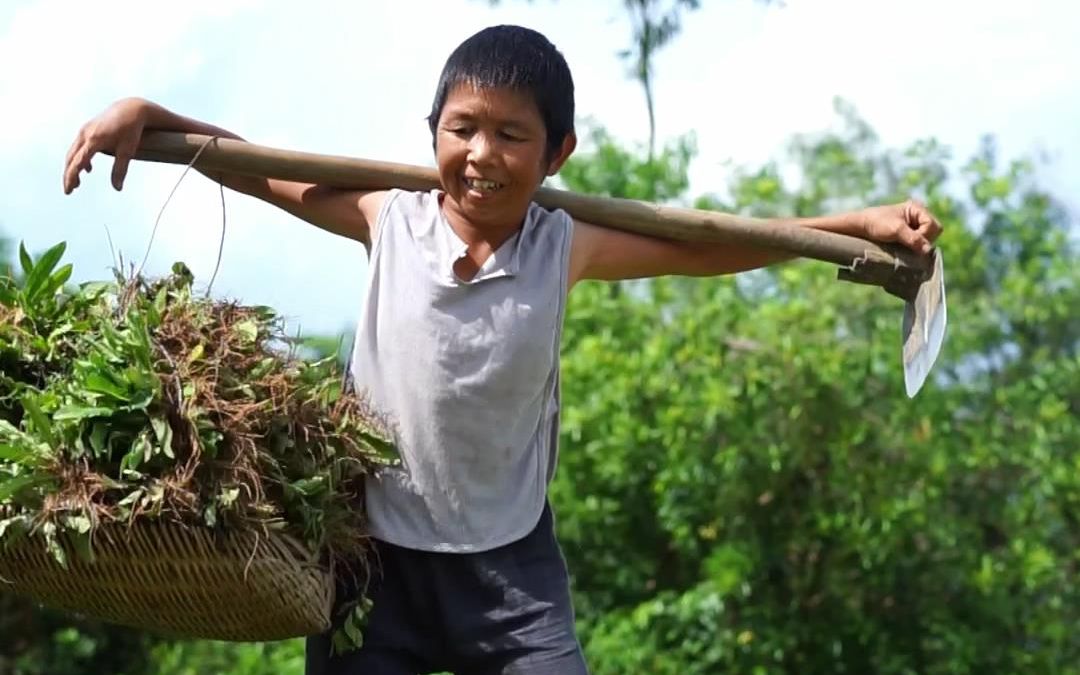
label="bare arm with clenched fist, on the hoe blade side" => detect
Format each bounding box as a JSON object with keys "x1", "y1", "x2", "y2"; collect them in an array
[{"x1": 570, "y1": 201, "x2": 942, "y2": 285}]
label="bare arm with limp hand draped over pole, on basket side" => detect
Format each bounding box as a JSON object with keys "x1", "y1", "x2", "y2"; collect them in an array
[{"x1": 64, "y1": 98, "x2": 386, "y2": 245}]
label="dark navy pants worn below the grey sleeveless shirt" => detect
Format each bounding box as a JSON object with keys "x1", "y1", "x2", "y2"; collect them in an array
[{"x1": 307, "y1": 507, "x2": 588, "y2": 675}]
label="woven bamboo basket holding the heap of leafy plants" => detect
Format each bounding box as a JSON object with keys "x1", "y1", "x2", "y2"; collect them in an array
[{"x1": 0, "y1": 523, "x2": 333, "y2": 642}]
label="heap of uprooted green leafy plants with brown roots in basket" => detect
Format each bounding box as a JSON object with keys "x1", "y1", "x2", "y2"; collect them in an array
[{"x1": 0, "y1": 243, "x2": 396, "y2": 565}]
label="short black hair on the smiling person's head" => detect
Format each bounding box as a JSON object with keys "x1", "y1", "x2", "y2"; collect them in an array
[{"x1": 428, "y1": 26, "x2": 573, "y2": 156}]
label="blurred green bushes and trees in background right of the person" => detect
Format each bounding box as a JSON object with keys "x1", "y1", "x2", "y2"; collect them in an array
[{"x1": 552, "y1": 101, "x2": 1080, "y2": 674}]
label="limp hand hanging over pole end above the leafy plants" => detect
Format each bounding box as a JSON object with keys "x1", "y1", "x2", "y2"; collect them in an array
[{"x1": 64, "y1": 98, "x2": 149, "y2": 194}]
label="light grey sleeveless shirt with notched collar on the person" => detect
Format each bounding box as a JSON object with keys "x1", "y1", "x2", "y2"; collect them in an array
[{"x1": 351, "y1": 190, "x2": 573, "y2": 552}]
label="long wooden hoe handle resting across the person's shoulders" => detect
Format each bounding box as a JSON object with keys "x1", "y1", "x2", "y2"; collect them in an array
[{"x1": 135, "y1": 132, "x2": 932, "y2": 286}]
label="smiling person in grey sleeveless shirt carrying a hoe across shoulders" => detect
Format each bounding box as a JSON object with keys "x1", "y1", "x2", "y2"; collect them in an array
[{"x1": 64, "y1": 26, "x2": 941, "y2": 675}]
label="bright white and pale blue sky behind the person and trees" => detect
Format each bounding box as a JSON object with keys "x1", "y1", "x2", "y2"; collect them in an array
[{"x1": 0, "y1": 0, "x2": 1080, "y2": 333}]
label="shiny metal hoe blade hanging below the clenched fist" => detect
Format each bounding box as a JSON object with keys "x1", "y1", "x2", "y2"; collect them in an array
[{"x1": 901, "y1": 251, "x2": 948, "y2": 397}]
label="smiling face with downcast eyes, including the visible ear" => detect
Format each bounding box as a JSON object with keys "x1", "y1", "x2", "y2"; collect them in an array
[{"x1": 435, "y1": 84, "x2": 576, "y2": 228}]
